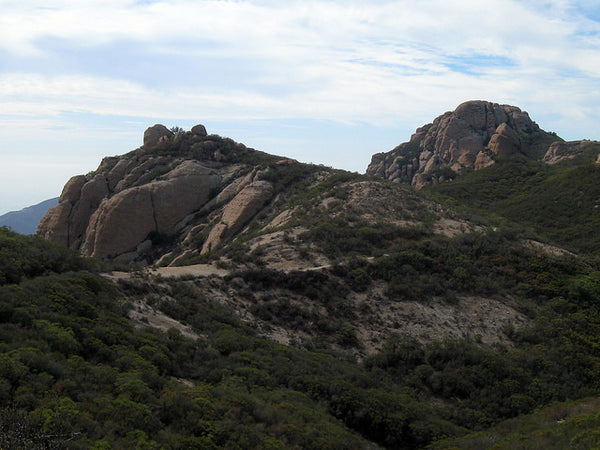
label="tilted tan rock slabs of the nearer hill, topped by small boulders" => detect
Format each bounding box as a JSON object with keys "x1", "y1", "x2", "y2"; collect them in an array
[{"x1": 38, "y1": 125, "x2": 273, "y2": 262}]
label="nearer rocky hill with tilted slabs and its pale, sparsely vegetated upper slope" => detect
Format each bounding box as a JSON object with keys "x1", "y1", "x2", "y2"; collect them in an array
[{"x1": 38, "y1": 125, "x2": 469, "y2": 267}]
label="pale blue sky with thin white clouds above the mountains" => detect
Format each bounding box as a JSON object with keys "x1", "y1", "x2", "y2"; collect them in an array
[{"x1": 0, "y1": 0, "x2": 600, "y2": 214}]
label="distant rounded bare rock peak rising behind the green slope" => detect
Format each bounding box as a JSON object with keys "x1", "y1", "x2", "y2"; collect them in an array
[{"x1": 367, "y1": 100, "x2": 548, "y2": 189}]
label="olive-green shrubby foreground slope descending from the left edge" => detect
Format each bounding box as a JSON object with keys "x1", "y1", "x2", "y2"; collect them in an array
[{"x1": 0, "y1": 273, "x2": 380, "y2": 448}]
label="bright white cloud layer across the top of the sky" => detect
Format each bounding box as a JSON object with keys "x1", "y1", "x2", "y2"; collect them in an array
[{"x1": 0, "y1": 0, "x2": 600, "y2": 99}]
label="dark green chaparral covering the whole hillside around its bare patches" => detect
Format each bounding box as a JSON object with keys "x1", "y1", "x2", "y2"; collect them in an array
[{"x1": 8, "y1": 144, "x2": 600, "y2": 449}]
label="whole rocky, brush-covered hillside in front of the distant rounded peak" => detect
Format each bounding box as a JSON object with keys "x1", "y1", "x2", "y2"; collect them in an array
[{"x1": 25, "y1": 105, "x2": 600, "y2": 448}]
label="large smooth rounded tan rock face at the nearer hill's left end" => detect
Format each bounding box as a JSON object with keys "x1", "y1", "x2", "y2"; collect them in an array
[{"x1": 38, "y1": 158, "x2": 221, "y2": 259}]
